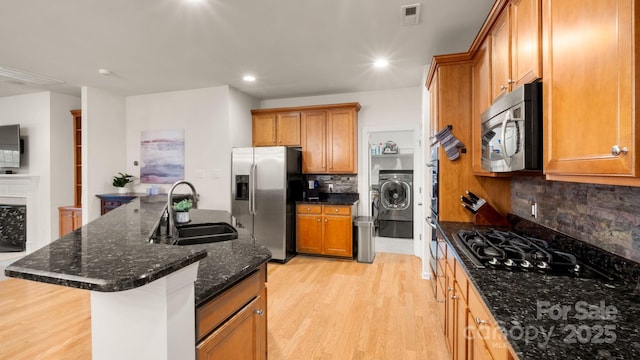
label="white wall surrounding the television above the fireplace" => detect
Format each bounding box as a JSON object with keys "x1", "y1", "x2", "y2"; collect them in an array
[{"x1": 0, "y1": 91, "x2": 80, "y2": 249}]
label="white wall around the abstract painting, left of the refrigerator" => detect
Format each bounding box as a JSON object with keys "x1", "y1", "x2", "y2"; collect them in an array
[{"x1": 127, "y1": 86, "x2": 258, "y2": 211}]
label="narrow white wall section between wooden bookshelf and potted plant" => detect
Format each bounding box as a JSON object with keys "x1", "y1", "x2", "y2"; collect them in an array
[{"x1": 82, "y1": 87, "x2": 128, "y2": 224}]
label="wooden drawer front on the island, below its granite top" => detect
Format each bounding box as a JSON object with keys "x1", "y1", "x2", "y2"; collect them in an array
[{"x1": 196, "y1": 270, "x2": 264, "y2": 341}]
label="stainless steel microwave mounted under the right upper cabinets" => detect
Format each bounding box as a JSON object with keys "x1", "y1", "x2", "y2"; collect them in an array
[{"x1": 481, "y1": 81, "x2": 542, "y2": 172}]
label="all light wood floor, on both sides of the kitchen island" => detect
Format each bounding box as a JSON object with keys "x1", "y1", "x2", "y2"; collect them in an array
[{"x1": 0, "y1": 253, "x2": 448, "y2": 360}]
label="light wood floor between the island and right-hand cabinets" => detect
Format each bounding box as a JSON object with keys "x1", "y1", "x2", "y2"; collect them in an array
[{"x1": 267, "y1": 253, "x2": 448, "y2": 360}]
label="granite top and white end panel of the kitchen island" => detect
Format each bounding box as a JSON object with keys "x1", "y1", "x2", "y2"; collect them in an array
[{"x1": 5, "y1": 196, "x2": 271, "y2": 359}]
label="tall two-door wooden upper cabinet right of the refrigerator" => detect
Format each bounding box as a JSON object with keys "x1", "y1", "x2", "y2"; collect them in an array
[{"x1": 301, "y1": 103, "x2": 360, "y2": 174}]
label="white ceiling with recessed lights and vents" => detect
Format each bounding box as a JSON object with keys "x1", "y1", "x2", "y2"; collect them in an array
[{"x1": 0, "y1": 0, "x2": 494, "y2": 99}]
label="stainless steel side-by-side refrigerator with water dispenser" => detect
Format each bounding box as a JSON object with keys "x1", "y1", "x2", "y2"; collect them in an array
[{"x1": 231, "y1": 146, "x2": 303, "y2": 262}]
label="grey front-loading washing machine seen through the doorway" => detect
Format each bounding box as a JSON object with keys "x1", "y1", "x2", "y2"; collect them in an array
[{"x1": 378, "y1": 170, "x2": 413, "y2": 238}]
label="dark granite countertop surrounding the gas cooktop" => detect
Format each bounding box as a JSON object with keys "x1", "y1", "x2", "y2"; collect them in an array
[{"x1": 439, "y1": 222, "x2": 640, "y2": 360}]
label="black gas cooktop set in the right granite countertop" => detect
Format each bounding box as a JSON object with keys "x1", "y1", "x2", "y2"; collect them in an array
[{"x1": 453, "y1": 230, "x2": 614, "y2": 281}]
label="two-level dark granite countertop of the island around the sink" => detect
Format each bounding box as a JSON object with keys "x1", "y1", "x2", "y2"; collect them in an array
[{"x1": 5, "y1": 196, "x2": 271, "y2": 306}]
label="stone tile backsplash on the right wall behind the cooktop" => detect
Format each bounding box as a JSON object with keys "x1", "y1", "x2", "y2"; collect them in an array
[{"x1": 511, "y1": 177, "x2": 640, "y2": 262}]
